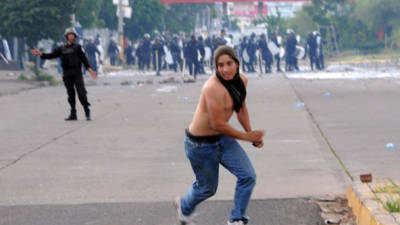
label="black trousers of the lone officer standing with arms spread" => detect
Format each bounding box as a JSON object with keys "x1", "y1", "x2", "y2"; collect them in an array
[{"x1": 63, "y1": 75, "x2": 90, "y2": 111}]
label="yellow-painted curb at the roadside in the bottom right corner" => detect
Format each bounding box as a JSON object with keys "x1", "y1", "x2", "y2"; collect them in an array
[{"x1": 347, "y1": 182, "x2": 400, "y2": 225}]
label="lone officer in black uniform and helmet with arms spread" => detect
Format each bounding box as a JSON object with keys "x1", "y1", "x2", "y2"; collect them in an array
[{"x1": 31, "y1": 28, "x2": 97, "y2": 121}]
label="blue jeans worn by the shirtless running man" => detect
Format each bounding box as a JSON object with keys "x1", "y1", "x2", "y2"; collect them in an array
[{"x1": 181, "y1": 136, "x2": 256, "y2": 223}]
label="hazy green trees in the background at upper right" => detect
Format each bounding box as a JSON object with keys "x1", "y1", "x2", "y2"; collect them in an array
[{"x1": 255, "y1": 0, "x2": 400, "y2": 52}]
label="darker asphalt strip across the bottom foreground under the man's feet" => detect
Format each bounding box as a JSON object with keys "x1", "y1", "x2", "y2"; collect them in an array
[{"x1": 0, "y1": 199, "x2": 323, "y2": 225}]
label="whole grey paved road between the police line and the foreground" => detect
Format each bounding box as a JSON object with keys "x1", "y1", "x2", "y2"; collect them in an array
[{"x1": 0, "y1": 69, "x2": 400, "y2": 225}]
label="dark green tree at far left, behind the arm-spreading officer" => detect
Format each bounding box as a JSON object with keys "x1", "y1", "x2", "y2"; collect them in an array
[{"x1": 0, "y1": 0, "x2": 77, "y2": 46}]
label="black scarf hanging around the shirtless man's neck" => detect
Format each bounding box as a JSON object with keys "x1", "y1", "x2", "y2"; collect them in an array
[{"x1": 217, "y1": 69, "x2": 246, "y2": 112}]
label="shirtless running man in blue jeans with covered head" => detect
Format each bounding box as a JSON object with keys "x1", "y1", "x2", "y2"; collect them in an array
[{"x1": 175, "y1": 46, "x2": 264, "y2": 225}]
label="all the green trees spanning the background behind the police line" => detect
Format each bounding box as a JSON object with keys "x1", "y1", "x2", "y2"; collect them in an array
[{"x1": 0, "y1": 0, "x2": 400, "y2": 51}]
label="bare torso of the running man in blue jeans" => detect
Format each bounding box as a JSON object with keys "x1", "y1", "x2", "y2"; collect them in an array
[{"x1": 189, "y1": 74, "x2": 243, "y2": 136}]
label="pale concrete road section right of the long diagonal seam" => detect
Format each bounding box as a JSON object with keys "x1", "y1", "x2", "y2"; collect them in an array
[{"x1": 291, "y1": 76, "x2": 400, "y2": 180}]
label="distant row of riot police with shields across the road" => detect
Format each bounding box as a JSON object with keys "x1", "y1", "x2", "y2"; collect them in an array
[{"x1": 84, "y1": 29, "x2": 324, "y2": 78}]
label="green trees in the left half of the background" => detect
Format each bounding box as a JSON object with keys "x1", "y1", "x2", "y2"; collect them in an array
[{"x1": 0, "y1": 0, "x2": 213, "y2": 46}]
